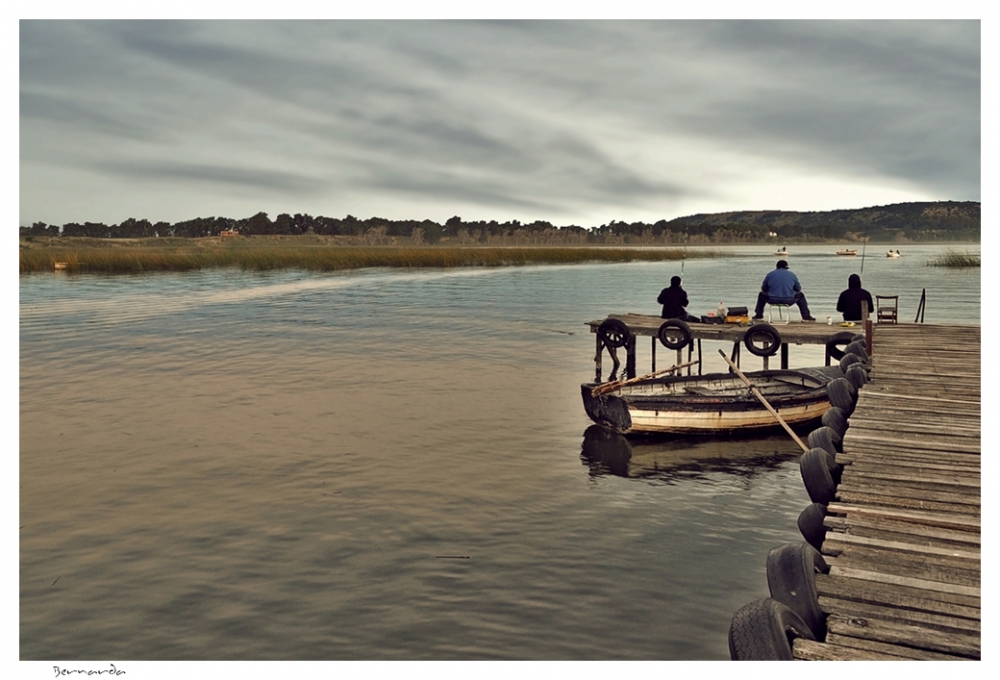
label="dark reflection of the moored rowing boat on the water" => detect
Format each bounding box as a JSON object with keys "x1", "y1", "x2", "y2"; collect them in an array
[{"x1": 580, "y1": 425, "x2": 801, "y2": 483}]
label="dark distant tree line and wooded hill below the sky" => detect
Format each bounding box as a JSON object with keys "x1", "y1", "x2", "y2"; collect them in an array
[{"x1": 20, "y1": 201, "x2": 981, "y2": 245}]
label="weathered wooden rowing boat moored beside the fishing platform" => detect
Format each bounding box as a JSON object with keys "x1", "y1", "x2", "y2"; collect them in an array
[{"x1": 581, "y1": 365, "x2": 844, "y2": 435}]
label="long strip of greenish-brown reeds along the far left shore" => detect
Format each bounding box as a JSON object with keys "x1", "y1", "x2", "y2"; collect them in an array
[{"x1": 20, "y1": 245, "x2": 725, "y2": 274}]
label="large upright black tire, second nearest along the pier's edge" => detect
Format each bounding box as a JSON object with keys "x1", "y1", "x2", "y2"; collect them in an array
[{"x1": 767, "y1": 543, "x2": 830, "y2": 640}]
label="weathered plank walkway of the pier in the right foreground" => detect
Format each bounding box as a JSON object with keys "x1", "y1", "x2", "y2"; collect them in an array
[{"x1": 792, "y1": 324, "x2": 981, "y2": 660}]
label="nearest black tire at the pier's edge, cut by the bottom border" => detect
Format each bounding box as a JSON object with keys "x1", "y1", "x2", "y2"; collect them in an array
[{"x1": 729, "y1": 597, "x2": 816, "y2": 661}]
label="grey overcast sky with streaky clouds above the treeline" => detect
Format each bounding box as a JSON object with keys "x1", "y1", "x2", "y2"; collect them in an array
[{"x1": 20, "y1": 21, "x2": 981, "y2": 227}]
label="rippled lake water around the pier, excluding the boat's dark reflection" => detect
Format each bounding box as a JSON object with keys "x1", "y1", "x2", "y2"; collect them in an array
[{"x1": 18, "y1": 246, "x2": 980, "y2": 660}]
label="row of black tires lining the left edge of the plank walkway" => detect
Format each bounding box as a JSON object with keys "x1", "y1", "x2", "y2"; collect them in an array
[{"x1": 729, "y1": 333, "x2": 871, "y2": 661}]
